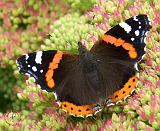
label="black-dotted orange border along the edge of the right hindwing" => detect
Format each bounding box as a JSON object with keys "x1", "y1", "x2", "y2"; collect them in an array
[{"x1": 110, "y1": 76, "x2": 139, "y2": 103}]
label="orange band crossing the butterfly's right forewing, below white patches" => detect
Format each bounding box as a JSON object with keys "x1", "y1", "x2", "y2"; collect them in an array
[{"x1": 102, "y1": 35, "x2": 138, "y2": 59}]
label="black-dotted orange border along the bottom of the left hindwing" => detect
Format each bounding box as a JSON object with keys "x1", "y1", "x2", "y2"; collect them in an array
[{"x1": 61, "y1": 102, "x2": 96, "y2": 116}]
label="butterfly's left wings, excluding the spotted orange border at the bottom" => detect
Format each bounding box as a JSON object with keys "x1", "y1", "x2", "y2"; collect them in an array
[{"x1": 17, "y1": 50, "x2": 98, "y2": 105}]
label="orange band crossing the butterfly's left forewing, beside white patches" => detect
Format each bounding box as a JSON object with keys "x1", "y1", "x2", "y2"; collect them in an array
[{"x1": 45, "y1": 51, "x2": 63, "y2": 88}]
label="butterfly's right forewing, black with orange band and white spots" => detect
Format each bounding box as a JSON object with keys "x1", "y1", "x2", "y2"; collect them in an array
[{"x1": 91, "y1": 15, "x2": 151, "y2": 62}]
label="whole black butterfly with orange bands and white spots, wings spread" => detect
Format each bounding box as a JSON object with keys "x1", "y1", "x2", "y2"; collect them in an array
[{"x1": 17, "y1": 15, "x2": 151, "y2": 116}]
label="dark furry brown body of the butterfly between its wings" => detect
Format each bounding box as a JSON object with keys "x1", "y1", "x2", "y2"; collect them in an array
[{"x1": 78, "y1": 42, "x2": 101, "y2": 91}]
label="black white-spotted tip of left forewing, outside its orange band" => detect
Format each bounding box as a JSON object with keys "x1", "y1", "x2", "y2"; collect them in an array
[{"x1": 16, "y1": 50, "x2": 57, "y2": 91}]
